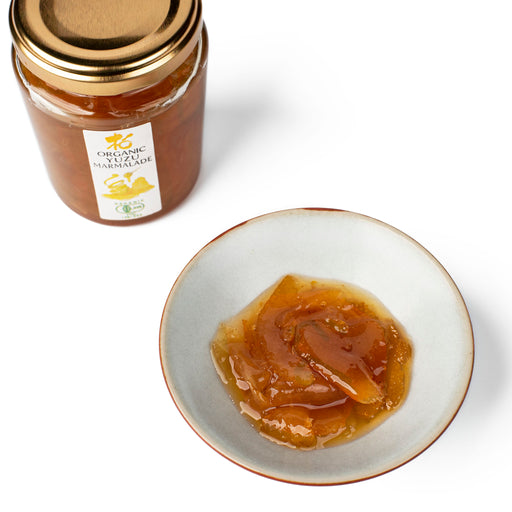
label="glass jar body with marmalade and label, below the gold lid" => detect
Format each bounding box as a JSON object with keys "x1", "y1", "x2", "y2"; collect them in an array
[{"x1": 13, "y1": 27, "x2": 208, "y2": 225}]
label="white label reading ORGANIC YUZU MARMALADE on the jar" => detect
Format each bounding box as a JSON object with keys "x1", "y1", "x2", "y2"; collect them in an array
[{"x1": 84, "y1": 123, "x2": 162, "y2": 220}]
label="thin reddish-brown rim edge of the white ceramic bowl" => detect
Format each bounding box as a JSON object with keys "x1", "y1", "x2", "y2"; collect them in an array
[{"x1": 159, "y1": 207, "x2": 475, "y2": 487}]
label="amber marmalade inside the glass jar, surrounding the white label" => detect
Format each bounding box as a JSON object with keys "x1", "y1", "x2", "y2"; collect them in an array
[{"x1": 13, "y1": 27, "x2": 208, "y2": 225}]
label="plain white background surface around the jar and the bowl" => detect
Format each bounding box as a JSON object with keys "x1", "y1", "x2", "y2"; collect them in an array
[{"x1": 0, "y1": 0, "x2": 512, "y2": 512}]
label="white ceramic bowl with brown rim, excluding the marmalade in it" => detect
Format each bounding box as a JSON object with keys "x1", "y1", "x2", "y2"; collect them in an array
[{"x1": 160, "y1": 209, "x2": 474, "y2": 485}]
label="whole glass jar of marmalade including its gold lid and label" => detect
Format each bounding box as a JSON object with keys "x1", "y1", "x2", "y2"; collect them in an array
[{"x1": 10, "y1": 0, "x2": 208, "y2": 225}]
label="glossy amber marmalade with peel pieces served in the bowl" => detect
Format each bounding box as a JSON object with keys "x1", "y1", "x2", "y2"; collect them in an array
[{"x1": 211, "y1": 275, "x2": 412, "y2": 450}]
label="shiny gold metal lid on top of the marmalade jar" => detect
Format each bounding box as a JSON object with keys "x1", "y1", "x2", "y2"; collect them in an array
[{"x1": 9, "y1": 0, "x2": 202, "y2": 96}]
